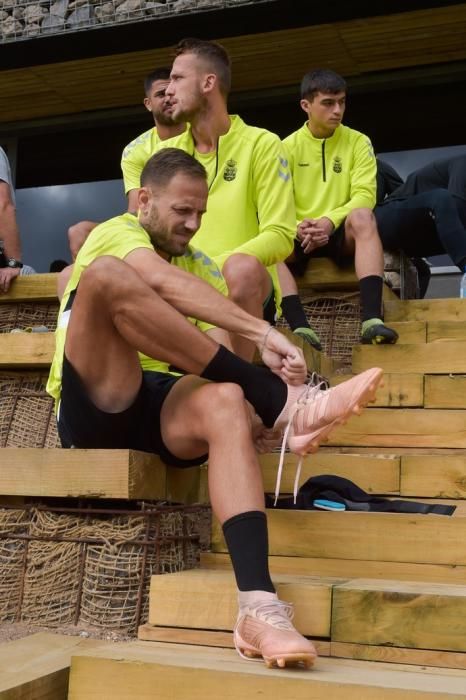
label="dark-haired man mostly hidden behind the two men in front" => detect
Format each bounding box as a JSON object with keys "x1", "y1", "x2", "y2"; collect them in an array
[{"x1": 68, "y1": 66, "x2": 185, "y2": 260}]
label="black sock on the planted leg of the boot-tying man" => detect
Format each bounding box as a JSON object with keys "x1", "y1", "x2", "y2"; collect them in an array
[{"x1": 223, "y1": 510, "x2": 275, "y2": 593}]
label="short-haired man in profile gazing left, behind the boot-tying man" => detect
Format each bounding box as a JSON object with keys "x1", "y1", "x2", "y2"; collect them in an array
[{"x1": 151, "y1": 39, "x2": 295, "y2": 359}]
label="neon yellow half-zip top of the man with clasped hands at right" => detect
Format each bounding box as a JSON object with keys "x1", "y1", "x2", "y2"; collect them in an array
[{"x1": 283, "y1": 122, "x2": 377, "y2": 228}]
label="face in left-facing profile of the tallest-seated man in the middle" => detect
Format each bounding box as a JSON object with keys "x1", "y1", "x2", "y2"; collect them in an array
[{"x1": 166, "y1": 53, "x2": 206, "y2": 124}]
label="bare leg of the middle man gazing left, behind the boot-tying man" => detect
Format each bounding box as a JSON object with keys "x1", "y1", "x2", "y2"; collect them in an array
[{"x1": 222, "y1": 254, "x2": 273, "y2": 362}]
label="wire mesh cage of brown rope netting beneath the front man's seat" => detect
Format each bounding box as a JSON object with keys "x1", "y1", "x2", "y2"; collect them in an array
[{"x1": 0, "y1": 503, "x2": 210, "y2": 634}]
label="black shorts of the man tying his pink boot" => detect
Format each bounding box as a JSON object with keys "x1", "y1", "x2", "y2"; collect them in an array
[{"x1": 58, "y1": 356, "x2": 207, "y2": 467}]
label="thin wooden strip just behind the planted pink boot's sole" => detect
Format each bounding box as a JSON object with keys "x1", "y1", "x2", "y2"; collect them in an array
[{"x1": 138, "y1": 623, "x2": 330, "y2": 656}]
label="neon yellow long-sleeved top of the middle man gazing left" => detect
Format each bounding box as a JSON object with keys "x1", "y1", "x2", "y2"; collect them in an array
[{"x1": 147, "y1": 116, "x2": 296, "y2": 304}]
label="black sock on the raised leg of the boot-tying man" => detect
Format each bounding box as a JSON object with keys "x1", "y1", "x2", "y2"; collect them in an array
[{"x1": 201, "y1": 345, "x2": 288, "y2": 428}]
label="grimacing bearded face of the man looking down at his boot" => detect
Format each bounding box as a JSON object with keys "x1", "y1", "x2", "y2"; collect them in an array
[{"x1": 139, "y1": 173, "x2": 208, "y2": 258}]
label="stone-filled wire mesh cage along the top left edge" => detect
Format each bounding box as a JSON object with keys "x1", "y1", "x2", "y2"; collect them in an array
[{"x1": 0, "y1": 0, "x2": 273, "y2": 42}]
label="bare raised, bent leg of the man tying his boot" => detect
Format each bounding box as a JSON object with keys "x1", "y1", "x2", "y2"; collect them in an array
[{"x1": 65, "y1": 257, "x2": 218, "y2": 413}]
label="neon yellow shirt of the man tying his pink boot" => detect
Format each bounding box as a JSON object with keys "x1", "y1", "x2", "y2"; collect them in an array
[{"x1": 47, "y1": 212, "x2": 228, "y2": 405}]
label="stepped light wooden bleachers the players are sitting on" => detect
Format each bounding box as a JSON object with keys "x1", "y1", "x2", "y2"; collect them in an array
[{"x1": 0, "y1": 272, "x2": 466, "y2": 700}]
